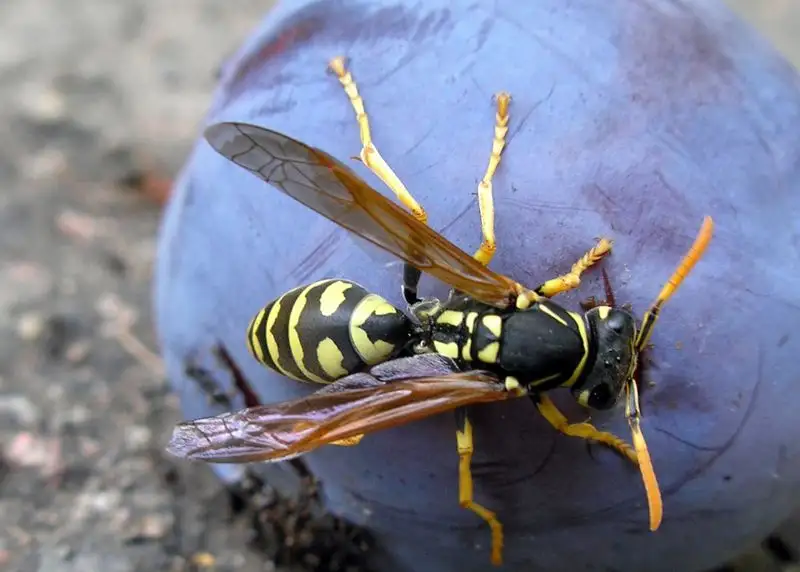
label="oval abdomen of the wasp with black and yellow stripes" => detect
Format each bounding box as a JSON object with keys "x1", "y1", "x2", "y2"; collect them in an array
[{"x1": 247, "y1": 280, "x2": 411, "y2": 383}]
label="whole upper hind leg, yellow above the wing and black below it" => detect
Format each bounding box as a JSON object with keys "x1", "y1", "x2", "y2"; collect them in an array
[{"x1": 328, "y1": 56, "x2": 428, "y2": 305}]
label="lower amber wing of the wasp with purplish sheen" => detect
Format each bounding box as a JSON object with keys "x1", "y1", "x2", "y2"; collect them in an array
[{"x1": 167, "y1": 371, "x2": 514, "y2": 463}]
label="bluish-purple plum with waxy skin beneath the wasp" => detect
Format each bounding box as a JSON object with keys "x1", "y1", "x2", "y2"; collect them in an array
[{"x1": 155, "y1": 0, "x2": 800, "y2": 572}]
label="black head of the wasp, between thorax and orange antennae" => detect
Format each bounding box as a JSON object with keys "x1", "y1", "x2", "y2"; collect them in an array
[{"x1": 572, "y1": 306, "x2": 636, "y2": 409}]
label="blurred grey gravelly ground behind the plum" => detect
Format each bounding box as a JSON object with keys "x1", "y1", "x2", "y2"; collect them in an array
[{"x1": 0, "y1": 0, "x2": 800, "y2": 572}]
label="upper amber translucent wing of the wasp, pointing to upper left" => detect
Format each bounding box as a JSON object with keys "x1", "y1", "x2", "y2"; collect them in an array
[{"x1": 205, "y1": 123, "x2": 520, "y2": 308}]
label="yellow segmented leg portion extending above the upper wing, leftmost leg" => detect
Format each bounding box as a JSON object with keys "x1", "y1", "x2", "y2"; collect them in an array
[{"x1": 329, "y1": 56, "x2": 428, "y2": 223}]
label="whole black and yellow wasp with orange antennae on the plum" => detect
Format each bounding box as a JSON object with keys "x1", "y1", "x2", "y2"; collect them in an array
[{"x1": 169, "y1": 57, "x2": 713, "y2": 565}]
